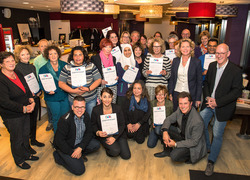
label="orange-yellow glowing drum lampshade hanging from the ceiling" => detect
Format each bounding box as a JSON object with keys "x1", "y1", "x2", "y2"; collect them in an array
[{"x1": 140, "y1": 5, "x2": 163, "y2": 18}]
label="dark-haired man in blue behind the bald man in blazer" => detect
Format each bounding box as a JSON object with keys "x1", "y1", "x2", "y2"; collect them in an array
[{"x1": 199, "y1": 39, "x2": 218, "y2": 81}]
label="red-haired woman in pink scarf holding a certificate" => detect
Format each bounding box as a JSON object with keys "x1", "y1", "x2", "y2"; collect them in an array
[{"x1": 91, "y1": 38, "x2": 118, "y2": 103}]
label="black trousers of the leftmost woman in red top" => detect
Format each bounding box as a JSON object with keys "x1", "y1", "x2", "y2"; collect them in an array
[{"x1": 4, "y1": 114, "x2": 30, "y2": 164}]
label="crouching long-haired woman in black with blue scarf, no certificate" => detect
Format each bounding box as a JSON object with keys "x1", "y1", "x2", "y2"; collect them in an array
[{"x1": 123, "y1": 80, "x2": 151, "y2": 144}]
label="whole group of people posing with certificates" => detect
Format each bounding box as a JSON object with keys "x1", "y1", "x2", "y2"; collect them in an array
[{"x1": 0, "y1": 29, "x2": 242, "y2": 176}]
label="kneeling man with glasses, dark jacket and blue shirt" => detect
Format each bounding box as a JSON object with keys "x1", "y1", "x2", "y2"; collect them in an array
[{"x1": 53, "y1": 96, "x2": 100, "y2": 175}]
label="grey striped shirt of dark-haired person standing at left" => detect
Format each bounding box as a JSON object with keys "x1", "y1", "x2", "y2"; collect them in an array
[{"x1": 59, "y1": 61, "x2": 101, "y2": 102}]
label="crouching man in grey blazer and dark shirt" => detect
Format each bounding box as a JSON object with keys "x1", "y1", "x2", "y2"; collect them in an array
[{"x1": 155, "y1": 92, "x2": 207, "y2": 163}]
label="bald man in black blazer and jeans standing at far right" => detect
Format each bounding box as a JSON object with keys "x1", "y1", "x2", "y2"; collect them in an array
[{"x1": 200, "y1": 43, "x2": 242, "y2": 176}]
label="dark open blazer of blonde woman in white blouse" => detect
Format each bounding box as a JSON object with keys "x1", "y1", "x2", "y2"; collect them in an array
[{"x1": 168, "y1": 57, "x2": 202, "y2": 101}]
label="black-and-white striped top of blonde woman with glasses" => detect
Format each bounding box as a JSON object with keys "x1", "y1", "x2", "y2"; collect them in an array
[{"x1": 142, "y1": 53, "x2": 171, "y2": 87}]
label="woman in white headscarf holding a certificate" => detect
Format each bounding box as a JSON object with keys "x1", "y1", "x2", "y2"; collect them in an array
[{"x1": 116, "y1": 44, "x2": 141, "y2": 106}]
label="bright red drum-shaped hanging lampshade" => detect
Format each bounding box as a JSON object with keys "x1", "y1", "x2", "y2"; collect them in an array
[{"x1": 188, "y1": 3, "x2": 216, "y2": 18}]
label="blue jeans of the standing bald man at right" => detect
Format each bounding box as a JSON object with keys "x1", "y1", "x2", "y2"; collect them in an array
[{"x1": 200, "y1": 107, "x2": 227, "y2": 162}]
